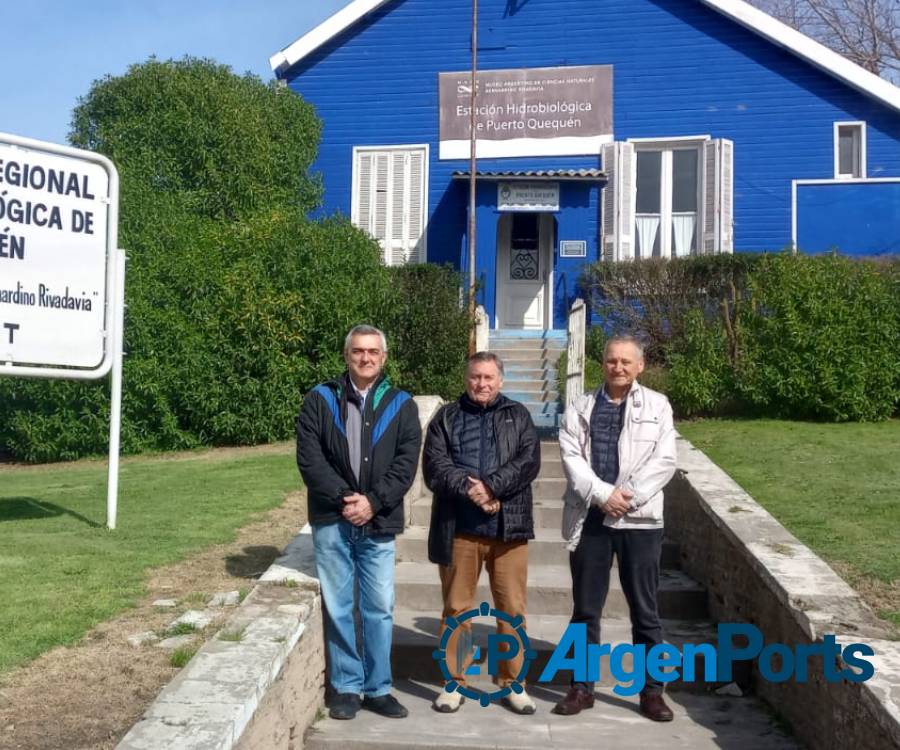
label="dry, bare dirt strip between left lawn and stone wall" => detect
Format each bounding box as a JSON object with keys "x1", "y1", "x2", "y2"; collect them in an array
[{"x1": 0, "y1": 490, "x2": 306, "y2": 750}]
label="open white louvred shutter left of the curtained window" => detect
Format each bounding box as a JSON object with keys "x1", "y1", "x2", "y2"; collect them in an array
[{"x1": 601, "y1": 142, "x2": 637, "y2": 260}]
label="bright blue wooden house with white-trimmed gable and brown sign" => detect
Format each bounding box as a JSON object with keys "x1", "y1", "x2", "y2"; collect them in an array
[{"x1": 271, "y1": 0, "x2": 900, "y2": 330}]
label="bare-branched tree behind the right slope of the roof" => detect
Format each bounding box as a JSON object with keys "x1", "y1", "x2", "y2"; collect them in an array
[{"x1": 750, "y1": 0, "x2": 900, "y2": 84}]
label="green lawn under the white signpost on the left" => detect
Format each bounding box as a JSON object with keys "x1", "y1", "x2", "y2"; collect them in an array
[{"x1": 0, "y1": 446, "x2": 300, "y2": 673}]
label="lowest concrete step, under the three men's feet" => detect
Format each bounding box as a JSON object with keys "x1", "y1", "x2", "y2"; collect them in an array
[{"x1": 304, "y1": 680, "x2": 800, "y2": 750}]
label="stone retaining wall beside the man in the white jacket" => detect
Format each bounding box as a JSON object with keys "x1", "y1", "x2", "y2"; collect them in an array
[{"x1": 666, "y1": 440, "x2": 900, "y2": 750}]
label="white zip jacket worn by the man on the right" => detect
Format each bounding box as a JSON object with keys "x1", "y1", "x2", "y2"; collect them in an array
[{"x1": 559, "y1": 381, "x2": 676, "y2": 550}]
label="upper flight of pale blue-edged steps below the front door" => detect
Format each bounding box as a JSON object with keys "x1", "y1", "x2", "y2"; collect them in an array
[{"x1": 489, "y1": 330, "x2": 566, "y2": 432}]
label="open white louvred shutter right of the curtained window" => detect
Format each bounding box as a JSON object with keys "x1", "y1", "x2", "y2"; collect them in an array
[{"x1": 702, "y1": 138, "x2": 734, "y2": 255}]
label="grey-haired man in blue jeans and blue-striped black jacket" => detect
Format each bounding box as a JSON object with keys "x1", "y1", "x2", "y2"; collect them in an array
[{"x1": 297, "y1": 326, "x2": 422, "y2": 719}]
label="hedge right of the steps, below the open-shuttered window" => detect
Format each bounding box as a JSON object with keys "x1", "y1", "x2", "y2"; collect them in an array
[{"x1": 585, "y1": 254, "x2": 900, "y2": 421}]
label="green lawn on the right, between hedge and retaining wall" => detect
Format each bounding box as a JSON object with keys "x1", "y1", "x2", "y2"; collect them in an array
[{"x1": 678, "y1": 419, "x2": 900, "y2": 625}]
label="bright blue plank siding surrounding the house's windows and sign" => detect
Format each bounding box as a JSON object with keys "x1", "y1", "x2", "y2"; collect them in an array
[{"x1": 286, "y1": 0, "x2": 900, "y2": 308}]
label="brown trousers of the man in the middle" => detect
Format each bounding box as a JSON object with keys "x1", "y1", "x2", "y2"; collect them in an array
[{"x1": 440, "y1": 534, "x2": 528, "y2": 687}]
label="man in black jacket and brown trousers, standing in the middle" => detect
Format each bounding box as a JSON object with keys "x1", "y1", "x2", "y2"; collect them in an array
[{"x1": 423, "y1": 352, "x2": 541, "y2": 714}]
